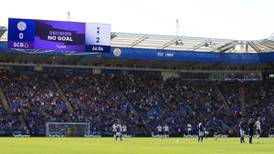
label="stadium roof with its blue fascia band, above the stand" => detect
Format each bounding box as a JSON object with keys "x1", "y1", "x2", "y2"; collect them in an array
[{"x1": 0, "y1": 27, "x2": 274, "y2": 72}]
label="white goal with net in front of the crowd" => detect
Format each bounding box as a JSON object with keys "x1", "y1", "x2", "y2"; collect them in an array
[{"x1": 46, "y1": 122, "x2": 90, "y2": 137}]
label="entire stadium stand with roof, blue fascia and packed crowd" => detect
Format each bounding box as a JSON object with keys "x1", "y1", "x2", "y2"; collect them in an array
[{"x1": 0, "y1": 21, "x2": 274, "y2": 136}]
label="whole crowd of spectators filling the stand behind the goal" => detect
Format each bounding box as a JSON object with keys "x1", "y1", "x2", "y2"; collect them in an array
[{"x1": 0, "y1": 70, "x2": 274, "y2": 135}]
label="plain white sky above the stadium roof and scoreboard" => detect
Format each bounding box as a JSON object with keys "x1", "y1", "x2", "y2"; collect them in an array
[{"x1": 0, "y1": 0, "x2": 274, "y2": 40}]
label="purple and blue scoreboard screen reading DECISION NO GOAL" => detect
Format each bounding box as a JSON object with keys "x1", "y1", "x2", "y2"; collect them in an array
[{"x1": 8, "y1": 18, "x2": 111, "y2": 52}]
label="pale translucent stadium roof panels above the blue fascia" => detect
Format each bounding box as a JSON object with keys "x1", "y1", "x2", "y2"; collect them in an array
[{"x1": 0, "y1": 27, "x2": 274, "y2": 53}]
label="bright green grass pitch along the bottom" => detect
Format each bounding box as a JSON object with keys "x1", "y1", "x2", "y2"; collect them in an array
[{"x1": 0, "y1": 138, "x2": 274, "y2": 154}]
